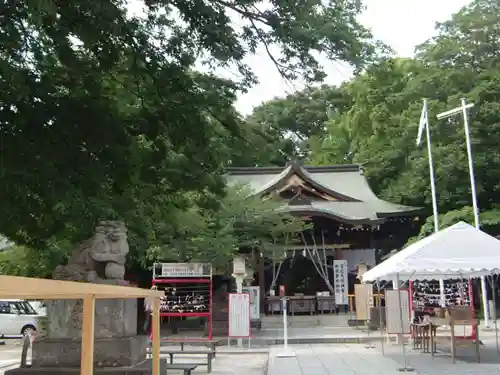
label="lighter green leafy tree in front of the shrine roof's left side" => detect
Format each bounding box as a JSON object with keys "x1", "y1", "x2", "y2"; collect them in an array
[{"x1": 148, "y1": 186, "x2": 307, "y2": 269}]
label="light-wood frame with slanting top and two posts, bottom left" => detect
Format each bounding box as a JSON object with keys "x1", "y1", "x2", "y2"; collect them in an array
[{"x1": 0, "y1": 275, "x2": 163, "y2": 375}]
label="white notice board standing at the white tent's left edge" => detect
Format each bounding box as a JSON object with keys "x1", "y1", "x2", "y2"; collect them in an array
[{"x1": 385, "y1": 289, "x2": 410, "y2": 334}]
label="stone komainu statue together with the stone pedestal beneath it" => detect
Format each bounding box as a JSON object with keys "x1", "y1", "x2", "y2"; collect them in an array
[{"x1": 32, "y1": 221, "x2": 141, "y2": 364}]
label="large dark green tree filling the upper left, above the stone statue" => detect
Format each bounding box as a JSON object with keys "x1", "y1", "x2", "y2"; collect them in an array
[{"x1": 0, "y1": 0, "x2": 375, "y2": 274}]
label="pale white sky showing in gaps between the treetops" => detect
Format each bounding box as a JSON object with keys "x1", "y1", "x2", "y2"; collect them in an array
[{"x1": 236, "y1": 0, "x2": 470, "y2": 114}]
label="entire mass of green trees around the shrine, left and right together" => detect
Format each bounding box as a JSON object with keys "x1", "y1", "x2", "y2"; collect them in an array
[{"x1": 0, "y1": 0, "x2": 500, "y2": 275}]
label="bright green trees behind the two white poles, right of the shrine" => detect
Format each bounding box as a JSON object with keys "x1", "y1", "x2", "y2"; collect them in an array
[{"x1": 250, "y1": 0, "x2": 500, "y2": 235}]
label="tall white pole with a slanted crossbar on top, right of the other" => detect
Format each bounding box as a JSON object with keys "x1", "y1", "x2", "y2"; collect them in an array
[{"x1": 437, "y1": 98, "x2": 490, "y2": 327}]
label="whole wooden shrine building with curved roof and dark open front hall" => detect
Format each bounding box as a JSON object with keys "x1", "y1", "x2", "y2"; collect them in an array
[{"x1": 226, "y1": 162, "x2": 421, "y2": 313}]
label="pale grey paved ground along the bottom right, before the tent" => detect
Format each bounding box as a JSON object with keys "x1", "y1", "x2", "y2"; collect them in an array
[{"x1": 268, "y1": 342, "x2": 500, "y2": 375}]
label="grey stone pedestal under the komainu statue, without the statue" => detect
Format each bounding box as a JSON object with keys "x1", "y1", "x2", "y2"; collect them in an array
[{"x1": 32, "y1": 299, "x2": 148, "y2": 368}]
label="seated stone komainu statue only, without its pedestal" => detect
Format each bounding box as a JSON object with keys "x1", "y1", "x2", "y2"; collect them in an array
[{"x1": 52, "y1": 221, "x2": 129, "y2": 284}]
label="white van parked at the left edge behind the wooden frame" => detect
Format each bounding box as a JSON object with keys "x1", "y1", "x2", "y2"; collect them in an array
[{"x1": 0, "y1": 299, "x2": 40, "y2": 337}]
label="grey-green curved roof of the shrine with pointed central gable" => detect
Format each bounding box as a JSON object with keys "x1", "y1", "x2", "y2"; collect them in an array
[{"x1": 226, "y1": 163, "x2": 421, "y2": 224}]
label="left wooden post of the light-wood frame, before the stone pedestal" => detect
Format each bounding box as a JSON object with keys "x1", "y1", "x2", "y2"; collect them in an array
[{"x1": 80, "y1": 294, "x2": 95, "y2": 375}]
